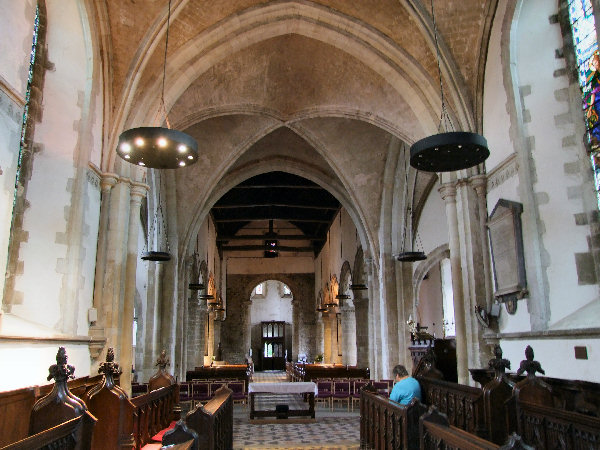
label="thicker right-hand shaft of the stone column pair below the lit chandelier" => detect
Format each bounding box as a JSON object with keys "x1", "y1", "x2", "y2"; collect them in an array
[{"x1": 119, "y1": 182, "x2": 148, "y2": 397}]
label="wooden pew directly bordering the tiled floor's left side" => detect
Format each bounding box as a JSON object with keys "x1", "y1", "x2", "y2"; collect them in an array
[{"x1": 185, "y1": 387, "x2": 233, "y2": 450}]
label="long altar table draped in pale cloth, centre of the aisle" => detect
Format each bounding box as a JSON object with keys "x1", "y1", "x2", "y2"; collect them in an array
[{"x1": 248, "y1": 381, "x2": 318, "y2": 419}]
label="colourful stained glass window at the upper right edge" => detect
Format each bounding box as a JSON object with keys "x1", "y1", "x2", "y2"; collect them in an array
[{"x1": 569, "y1": 0, "x2": 600, "y2": 207}]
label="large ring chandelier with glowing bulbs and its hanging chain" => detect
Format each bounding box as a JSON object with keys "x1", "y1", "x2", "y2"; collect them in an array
[{"x1": 117, "y1": 0, "x2": 198, "y2": 169}]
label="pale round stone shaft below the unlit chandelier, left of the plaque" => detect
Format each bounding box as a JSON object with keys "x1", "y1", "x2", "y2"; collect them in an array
[{"x1": 439, "y1": 184, "x2": 469, "y2": 384}]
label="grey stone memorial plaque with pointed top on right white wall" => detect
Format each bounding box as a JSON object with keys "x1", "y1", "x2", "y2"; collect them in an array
[{"x1": 487, "y1": 199, "x2": 527, "y2": 314}]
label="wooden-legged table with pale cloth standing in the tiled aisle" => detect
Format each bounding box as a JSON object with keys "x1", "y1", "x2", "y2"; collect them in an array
[{"x1": 248, "y1": 381, "x2": 318, "y2": 419}]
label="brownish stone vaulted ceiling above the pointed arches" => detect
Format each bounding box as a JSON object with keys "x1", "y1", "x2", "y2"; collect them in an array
[{"x1": 95, "y1": 0, "x2": 497, "y2": 250}]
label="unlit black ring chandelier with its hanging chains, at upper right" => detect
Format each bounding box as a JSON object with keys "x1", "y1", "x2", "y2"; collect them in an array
[{"x1": 410, "y1": 0, "x2": 490, "y2": 172}]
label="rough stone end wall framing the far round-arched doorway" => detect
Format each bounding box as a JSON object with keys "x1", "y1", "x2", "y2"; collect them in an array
[{"x1": 221, "y1": 273, "x2": 316, "y2": 363}]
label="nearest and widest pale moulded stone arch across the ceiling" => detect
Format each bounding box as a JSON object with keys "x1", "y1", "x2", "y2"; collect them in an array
[{"x1": 108, "y1": 1, "x2": 473, "y2": 171}]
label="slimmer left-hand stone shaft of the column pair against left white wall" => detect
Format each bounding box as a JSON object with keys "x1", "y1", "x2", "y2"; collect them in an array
[{"x1": 89, "y1": 173, "x2": 118, "y2": 362}]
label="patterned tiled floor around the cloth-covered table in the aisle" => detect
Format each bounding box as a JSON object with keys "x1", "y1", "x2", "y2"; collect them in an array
[{"x1": 233, "y1": 372, "x2": 360, "y2": 450}]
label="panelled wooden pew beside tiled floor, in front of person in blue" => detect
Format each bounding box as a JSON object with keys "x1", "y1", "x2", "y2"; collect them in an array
[{"x1": 360, "y1": 387, "x2": 426, "y2": 450}]
